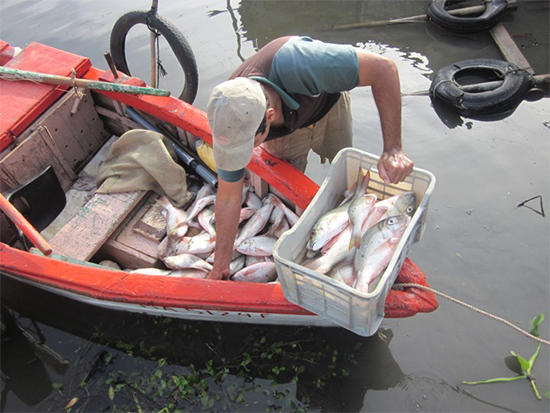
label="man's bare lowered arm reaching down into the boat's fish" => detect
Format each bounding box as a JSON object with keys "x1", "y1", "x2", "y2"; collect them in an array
[{"x1": 208, "y1": 178, "x2": 244, "y2": 280}]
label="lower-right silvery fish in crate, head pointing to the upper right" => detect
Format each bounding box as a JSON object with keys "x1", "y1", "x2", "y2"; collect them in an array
[{"x1": 353, "y1": 215, "x2": 411, "y2": 293}]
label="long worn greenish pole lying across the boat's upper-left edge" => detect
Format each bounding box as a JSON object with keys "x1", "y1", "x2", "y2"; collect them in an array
[{"x1": 0, "y1": 66, "x2": 170, "y2": 96}]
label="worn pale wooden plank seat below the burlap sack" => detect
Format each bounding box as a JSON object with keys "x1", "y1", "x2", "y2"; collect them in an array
[{"x1": 50, "y1": 191, "x2": 147, "y2": 261}]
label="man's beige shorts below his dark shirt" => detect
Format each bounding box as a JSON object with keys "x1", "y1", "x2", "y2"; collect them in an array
[{"x1": 262, "y1": 92, "x2": 353, "y2": 172}]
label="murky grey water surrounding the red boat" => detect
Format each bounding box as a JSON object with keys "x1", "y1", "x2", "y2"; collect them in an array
[{"x1": 0, "y1": 0, "x2": 550, "y2": 412}]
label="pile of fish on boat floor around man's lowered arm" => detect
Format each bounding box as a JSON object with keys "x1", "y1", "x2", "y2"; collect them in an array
[{"x1": 132, "y1": 183, "x2": 298, "y2": 283}]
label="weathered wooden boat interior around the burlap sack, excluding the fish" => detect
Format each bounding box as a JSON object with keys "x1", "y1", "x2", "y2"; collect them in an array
[{"x1": 0, "y1": 85, "x2": 268, "y2": 269}]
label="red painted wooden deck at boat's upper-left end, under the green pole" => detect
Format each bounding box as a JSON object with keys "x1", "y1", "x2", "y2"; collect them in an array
[{"x1": 0, "y1": 43, "x2": 92, "y2": 151}]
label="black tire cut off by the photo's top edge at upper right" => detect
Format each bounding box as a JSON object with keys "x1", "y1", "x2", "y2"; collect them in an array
[{"x1": 428, "y1": 0, "x2": 508, "y2": 33}]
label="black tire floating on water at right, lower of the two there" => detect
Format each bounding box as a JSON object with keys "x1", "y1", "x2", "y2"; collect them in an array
[{"x1": 430, "y1": 59, "x2": 533, "y2": 116}]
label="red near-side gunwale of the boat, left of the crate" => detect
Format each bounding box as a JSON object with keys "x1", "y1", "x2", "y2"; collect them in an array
[{"x1": 0, "y1": 244, "x2": 312, "y2": 315}]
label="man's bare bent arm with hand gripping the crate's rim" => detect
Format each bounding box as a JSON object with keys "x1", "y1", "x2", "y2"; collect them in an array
[{"x1": 356, "y1": 49, "x2": 413, "y2": 183}]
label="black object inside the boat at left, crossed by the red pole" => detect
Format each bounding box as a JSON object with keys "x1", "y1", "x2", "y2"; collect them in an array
[{"x1": 3, "y1": 166, "x2": 67, "y2": 249}]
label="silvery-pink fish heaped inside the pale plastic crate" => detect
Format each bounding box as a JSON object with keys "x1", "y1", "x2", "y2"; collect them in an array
[{"x1": 303, "y1": 168, "x2": 417, "y2": 293}]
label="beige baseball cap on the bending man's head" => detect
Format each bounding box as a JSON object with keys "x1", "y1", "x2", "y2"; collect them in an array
[{"x1": 207, "y1": 77, "x2": 267, "y2": 171}]
